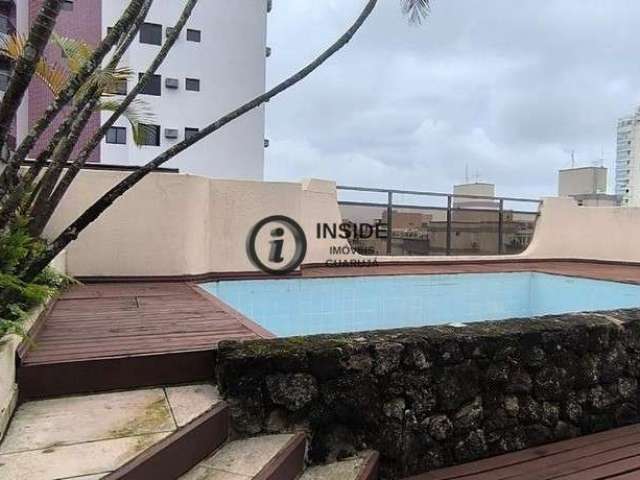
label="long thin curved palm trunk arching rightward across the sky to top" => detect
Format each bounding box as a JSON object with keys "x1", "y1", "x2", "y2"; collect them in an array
[{"x1": 23, "y1": 0, "x2": 378, "y2": 281}]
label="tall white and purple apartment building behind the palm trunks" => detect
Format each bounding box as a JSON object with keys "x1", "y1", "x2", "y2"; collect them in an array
[{"x1": 0, "y1": 0, "x2": 271, "y2": 180}]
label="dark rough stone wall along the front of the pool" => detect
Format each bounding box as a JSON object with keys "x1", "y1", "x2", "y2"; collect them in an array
[{"x1": 217, "y1": 310, "x2": 640, "y2": 478}]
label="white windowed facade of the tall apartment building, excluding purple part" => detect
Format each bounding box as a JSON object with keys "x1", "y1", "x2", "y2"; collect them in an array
[{"x1": 101, "y1": 0, "x2": 267, "y2": 180}]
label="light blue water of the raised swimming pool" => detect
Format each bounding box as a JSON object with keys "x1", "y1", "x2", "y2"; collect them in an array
[{"x1": 202, "y1": 272, "x2": 640, "y2": 337}]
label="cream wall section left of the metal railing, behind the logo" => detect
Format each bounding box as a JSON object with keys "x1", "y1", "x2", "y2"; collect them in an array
[{"x1": 46, "y1": 170, "x2": 346, "y2": 276}]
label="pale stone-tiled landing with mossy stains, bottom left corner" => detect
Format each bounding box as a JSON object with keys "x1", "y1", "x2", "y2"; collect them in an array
[{"x1": 0, "y1": 384, "x2": 220, "y2": 480}]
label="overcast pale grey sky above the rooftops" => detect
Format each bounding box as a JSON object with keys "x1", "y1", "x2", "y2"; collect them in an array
[{"x1": 265, "y1": 0, "x2": 640, "y2": 196}]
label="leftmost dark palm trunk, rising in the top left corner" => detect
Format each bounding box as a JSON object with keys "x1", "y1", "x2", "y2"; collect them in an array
[{"x1": 0, "y1": 0, "x2": 62, "y2": 182}]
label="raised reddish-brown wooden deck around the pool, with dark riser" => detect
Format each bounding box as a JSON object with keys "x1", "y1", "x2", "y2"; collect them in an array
[{"x1": 18, "y1": 260, "x2": 640, "y2": 398}]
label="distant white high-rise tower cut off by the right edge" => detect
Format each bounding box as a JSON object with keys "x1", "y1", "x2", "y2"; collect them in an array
[{"x1": 615, "y1": 109, "x2": 640, "y2": 207}]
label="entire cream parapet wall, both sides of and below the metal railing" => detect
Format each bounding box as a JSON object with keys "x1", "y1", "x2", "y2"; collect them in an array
[{"x1": 46, "y1": 170, "x2": 640, "y2": 276}]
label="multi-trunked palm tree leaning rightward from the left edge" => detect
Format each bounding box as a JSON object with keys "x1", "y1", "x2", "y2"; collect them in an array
[{"x1": 0, "y1": 0, "x2": 429, "y2": 280}]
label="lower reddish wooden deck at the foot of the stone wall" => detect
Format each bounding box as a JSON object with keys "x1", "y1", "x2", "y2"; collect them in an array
[{"x1": 407, "y1": 425, "x2": 640, "y2": 480}]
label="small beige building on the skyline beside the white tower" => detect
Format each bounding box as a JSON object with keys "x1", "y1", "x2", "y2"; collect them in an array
[{"x1": 558, "y1": 167, "x2": 619, "y2": 207}]
